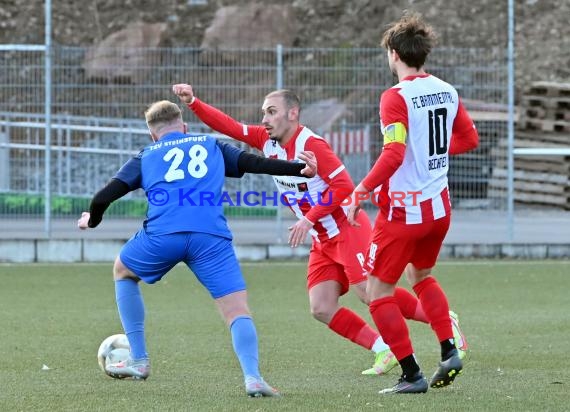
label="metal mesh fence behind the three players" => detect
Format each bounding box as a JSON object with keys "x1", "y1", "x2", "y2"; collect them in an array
[{"x1": 0, "y1": 46, "x2": 507, "y2": 229}]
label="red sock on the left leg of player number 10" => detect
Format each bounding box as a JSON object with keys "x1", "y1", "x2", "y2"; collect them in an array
[{"x1": 369, "y1": 296, "x2": 414, "y2": 360}]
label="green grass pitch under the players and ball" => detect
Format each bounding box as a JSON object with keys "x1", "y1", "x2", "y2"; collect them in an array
[{"x1": 0, "y1": 261, "x2": 570, "y2": 411}]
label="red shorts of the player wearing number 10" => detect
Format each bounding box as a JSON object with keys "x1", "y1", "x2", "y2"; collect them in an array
[{"x1": 364, "y1": 215, "x2": 451, "y2": 284}]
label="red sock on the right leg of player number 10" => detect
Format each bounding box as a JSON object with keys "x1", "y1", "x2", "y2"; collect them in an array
[{"x1": 414, "y1": 276, "x2": 453, "y2": 342}]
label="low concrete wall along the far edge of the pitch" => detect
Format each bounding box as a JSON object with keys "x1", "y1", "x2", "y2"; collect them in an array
[{"x1": 0, "y1": 239, "x2": 570, "y2": 263}]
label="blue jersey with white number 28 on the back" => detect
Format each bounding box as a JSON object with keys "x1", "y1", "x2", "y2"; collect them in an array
[{"x1": 115, "y1": 132, "x2": 242, "y2": 239}]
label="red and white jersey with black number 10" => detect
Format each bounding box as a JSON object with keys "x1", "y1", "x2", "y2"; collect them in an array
[{"x1": 372, "y1": 74, "x2": 475, "y2": 224}]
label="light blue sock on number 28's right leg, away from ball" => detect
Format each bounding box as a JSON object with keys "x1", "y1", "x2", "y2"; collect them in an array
[{"x1": 230, "y1": 316, "x2": 261, "y2": 378}]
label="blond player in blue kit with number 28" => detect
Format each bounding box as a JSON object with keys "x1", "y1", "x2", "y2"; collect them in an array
[{"x1": 78, "y1": 101, "x2": 317, "y2": 397}]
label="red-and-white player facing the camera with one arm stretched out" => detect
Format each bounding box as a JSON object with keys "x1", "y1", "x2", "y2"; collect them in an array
[{"x1": 173, "y1": 84, "x2": 442, "y2": 374}]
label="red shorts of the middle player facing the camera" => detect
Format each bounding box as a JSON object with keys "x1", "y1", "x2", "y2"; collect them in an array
[{"x1": 307, "y1": 210, "x2": 372, "y2": 295}]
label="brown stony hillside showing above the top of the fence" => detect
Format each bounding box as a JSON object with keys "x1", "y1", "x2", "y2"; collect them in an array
[{"x1": 0, "y1": 0, "x2": 570, "y2": 96}]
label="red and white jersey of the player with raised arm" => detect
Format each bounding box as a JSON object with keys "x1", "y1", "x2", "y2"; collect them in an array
[{"x1": 189, "y1": 99, "x2": 354, "y2": 242}]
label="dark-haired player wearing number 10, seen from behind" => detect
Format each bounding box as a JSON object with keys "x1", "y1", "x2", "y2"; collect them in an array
[{"x1": 348, "y1": 13, "x2": 479, "y2": 393}]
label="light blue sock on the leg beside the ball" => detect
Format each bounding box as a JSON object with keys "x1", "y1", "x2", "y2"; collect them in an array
[{"x1": 115, "y1": 279, "x2": 148, "y2": 359}]
